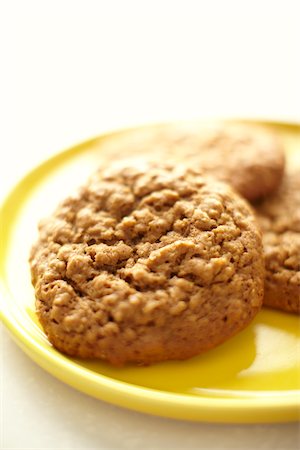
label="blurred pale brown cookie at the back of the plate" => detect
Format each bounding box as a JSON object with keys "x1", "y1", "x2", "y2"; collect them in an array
[{"x1": 99, "y1": 122, "x2": 285, "y2": 200}]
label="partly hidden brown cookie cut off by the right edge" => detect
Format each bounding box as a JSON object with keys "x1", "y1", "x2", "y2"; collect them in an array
[{"x1": 257, "y1": 169, "x2": 300, "y2": 314}]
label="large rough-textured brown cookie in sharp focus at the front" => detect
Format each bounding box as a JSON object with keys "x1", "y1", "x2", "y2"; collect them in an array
[{"x1": 30, "y1": 165, "x2": 264, "y2": 365}]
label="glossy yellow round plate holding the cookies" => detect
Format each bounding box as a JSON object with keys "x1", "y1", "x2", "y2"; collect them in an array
[{"x1": 0, "y1": 119, "x2": 300, "y2": 423}]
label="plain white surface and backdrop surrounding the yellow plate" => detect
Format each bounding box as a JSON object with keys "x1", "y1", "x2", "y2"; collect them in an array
[{"x1": 0, "y1": 0, "x2": 300, "y2": 450}]
